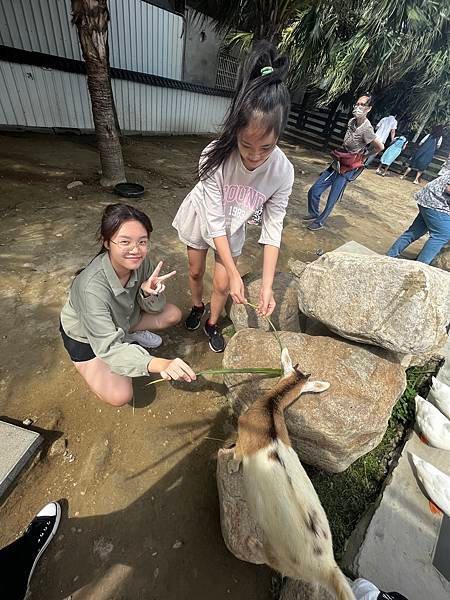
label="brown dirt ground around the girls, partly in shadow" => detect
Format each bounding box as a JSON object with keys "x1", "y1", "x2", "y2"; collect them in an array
[{"x1": 0, "y1": 134, "x2": 424, "y2": 600}]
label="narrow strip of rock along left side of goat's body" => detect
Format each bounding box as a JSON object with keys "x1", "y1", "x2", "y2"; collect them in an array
[{"x1": 216, "y1": 448, "x2": 267, "y2": 565}]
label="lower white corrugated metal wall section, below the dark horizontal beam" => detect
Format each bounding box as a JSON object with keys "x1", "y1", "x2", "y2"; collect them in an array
[{"x1": 0, "y1": 61, "x2": 229, "y2": 134}]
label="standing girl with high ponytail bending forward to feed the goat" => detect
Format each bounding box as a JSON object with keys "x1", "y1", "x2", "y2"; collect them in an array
[{"x1": 173, "y1": 42, "x2": 294, "y2": 352}]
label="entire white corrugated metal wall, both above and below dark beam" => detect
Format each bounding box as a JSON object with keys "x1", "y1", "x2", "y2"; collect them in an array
[{"x1": 0, "y1": 0, "x2": 229, "y2": 133}]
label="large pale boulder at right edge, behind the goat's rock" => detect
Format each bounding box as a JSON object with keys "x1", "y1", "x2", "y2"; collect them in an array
[{"x1": 294, "y1": 251, "x2": 450, "y2": 354}]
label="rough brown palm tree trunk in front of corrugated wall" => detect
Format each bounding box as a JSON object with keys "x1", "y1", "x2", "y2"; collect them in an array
[{"x1": 71, "y1": 0, "x2": 126, "y2": 186}]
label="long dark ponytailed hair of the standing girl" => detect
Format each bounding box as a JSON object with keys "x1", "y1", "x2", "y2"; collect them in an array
[{"x1": 199, "y1": 41, "x2": 291, "y2": 179}]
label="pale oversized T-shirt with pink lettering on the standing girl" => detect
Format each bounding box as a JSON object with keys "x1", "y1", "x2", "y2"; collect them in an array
[{"x1": 173, "y1": 142, "x2": 294, "y2": 249}]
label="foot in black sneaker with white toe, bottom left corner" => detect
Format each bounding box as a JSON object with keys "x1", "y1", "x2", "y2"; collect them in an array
[{"x1": 0, "y1": 502, "x2": 61, "y2": 600}]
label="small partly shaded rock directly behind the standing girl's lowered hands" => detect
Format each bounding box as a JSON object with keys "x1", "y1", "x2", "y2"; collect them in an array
[{"x1": 230, "y1": 273, "x2": 301, "y2": 331}]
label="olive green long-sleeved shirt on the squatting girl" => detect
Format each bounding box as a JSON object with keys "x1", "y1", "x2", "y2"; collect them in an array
[{"x1": 61, "y1": 252, "x2": 166, "y2": 377}]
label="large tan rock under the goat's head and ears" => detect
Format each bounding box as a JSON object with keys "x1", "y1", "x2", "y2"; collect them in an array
[{"x1": 223, "y1": 329, "x2": 406, "y2": 473}]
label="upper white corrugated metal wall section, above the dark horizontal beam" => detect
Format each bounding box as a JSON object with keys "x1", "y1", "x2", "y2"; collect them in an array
[{"x1": 0, "y1": 0, "x2": 184, "y2": 79}]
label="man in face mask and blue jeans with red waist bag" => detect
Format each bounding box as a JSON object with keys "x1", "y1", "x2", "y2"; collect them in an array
[{"x1": 303, "y1": 94, "x2": 384, "y2": 231}]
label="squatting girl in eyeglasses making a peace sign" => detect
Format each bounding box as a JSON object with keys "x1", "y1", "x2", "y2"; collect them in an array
[{"x1": 60, "y1": 204, "x2": 195, "y2": 406}]
